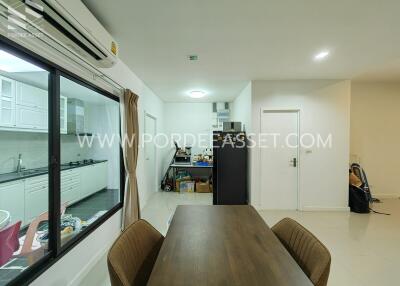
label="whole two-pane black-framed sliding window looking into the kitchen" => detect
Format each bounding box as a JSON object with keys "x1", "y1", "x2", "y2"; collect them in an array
[{"x1": 0, "y1": 41, "x2": 124, "y2": 285}]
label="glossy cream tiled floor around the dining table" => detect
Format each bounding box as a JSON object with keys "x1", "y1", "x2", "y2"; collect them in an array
[{"x1": 142, "y1": 192, "x2": 400, "y2": 286}]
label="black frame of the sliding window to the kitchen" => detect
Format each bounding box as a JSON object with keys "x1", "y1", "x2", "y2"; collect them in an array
[{"x1": 0, "y1": 35, "x2": 125, "y2": 286}]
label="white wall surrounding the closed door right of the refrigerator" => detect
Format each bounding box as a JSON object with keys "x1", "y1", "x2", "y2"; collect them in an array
[{"x1": 251, "y1": 80, "x2": 350, "y2": 210}]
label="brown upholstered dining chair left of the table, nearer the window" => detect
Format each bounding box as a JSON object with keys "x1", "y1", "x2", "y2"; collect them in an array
[{"x1": 107, "y1": 220, "x2": 164, "y2": 286}]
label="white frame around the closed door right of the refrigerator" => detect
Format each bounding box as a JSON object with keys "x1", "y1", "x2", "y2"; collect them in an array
[{"x1": 258, "y1": 107, "x2": 303, "y2": 211}]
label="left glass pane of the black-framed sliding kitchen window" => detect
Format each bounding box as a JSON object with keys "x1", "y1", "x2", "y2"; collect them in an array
[{"x1": 0, "y1": 49, "x2": 49, "y2": 285}]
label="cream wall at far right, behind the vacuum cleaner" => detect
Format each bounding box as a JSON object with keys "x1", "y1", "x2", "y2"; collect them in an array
[{"x1": 351, "y1": 82, "x2": 400, "y2": 198}]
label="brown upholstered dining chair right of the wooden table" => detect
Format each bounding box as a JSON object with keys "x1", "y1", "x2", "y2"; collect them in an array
[{"x1": 272, "y1": 218, "x2": 331, "y2": 286}]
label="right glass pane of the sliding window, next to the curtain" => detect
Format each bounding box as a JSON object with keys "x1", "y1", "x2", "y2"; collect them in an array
[{"x1": 60, "y1": 76, "x2": 121, "y2": 245}]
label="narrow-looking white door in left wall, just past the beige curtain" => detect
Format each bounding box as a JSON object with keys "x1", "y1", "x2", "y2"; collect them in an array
[{"x1": 144, "y1": 114, "x2": 157, "y2": 192}]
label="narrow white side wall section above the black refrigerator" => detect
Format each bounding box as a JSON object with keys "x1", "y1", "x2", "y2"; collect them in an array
[{"x1": 231, "y1": 82, "x2": 251, "y2": 132}]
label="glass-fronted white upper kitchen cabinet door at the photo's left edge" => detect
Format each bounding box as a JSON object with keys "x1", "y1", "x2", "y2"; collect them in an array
[{"x1": 0, "y1": 76, "x2": 15, "y2": 127}]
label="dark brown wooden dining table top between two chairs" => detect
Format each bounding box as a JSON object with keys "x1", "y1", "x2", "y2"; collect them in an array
[{"x1": 148, "y1": 206, "x2": 312, "y2": 286}]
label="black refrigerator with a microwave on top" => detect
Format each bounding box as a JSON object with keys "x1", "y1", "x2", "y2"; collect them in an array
[{"x1": 213, "y1": 131, "x2": 248, "y2": 205}]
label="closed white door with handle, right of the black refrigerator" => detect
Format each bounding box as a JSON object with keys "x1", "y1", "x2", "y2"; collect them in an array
[{"x1": 260, "y1": 110, "x2": 299, "y2": 210}]
